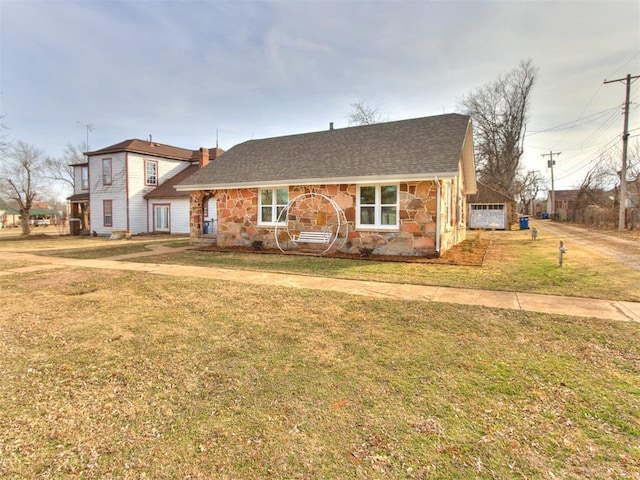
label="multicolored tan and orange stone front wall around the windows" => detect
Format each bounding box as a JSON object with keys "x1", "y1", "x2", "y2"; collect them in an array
[{"x1": 191, "y1": 181, "x2": 458, "y2": 256}]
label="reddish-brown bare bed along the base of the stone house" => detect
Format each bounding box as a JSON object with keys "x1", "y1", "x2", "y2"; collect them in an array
[{"x1": 196, "y1": 239, "x2": 491, "y2": 266}]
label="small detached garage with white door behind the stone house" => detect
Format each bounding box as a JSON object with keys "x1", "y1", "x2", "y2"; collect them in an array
[{"x1": 467, "y1": 182, "x2": 516, "y2": 230}]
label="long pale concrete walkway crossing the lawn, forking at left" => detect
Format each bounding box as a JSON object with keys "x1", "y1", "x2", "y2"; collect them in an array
[{"x1": 0, "y1": 247, "x2": 640, "y2": 322}]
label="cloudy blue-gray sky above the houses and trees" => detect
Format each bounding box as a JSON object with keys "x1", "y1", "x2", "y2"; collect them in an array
[{"x1": 0, "y1": 0, "x2": 640, "y2": 199}]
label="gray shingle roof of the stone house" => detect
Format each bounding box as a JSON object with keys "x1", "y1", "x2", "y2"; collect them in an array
[{"x1": 178, "y1": 114, "x2": 470, "y2": 190}]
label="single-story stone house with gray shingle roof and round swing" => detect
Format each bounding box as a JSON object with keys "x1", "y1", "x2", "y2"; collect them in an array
[{"x1": 176, "y1": 114, "x2": 476, "y2": 256}]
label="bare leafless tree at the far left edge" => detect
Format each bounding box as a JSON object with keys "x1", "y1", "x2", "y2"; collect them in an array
[{"x1": 0, "y1": 141, "x2": 46, "y2": 235}]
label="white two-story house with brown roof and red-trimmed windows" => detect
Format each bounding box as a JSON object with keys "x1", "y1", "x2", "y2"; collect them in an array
[{"x1": 69, "y1": 139, "x2": 222, "y2": 235}]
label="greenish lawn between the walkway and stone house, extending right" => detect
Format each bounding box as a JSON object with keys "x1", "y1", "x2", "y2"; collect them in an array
[{"x1": 124, "y1": 232, "x2": 640, "y2": 301}]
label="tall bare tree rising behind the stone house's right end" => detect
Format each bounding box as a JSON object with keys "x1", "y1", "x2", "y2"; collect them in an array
[{"x1": 458, "y1": 59, "x2": 538, "y2": 195}]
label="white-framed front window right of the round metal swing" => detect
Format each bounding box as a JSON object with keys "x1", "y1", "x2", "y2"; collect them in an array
[{"x1": 356, "y1": 185, "x2": 400, "y2": 230}]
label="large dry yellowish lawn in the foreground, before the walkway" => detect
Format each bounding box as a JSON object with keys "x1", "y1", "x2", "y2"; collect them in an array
[{"x1": 0, "y1": 270, "x2": 640, "y2": 479}]
